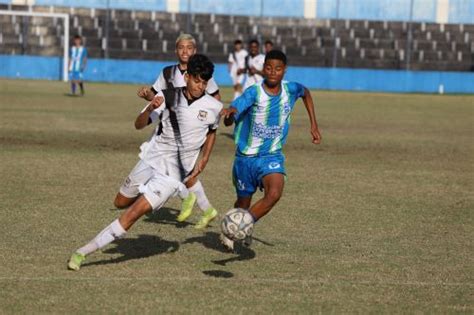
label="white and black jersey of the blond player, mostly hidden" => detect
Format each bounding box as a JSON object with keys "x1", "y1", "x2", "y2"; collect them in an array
[{"x1": 152, "y1": 65, "x2": 219, "y2": 96}]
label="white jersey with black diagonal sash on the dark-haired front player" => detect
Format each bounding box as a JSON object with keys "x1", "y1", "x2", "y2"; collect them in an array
[{"x1": 140, "y1": 87, "x2": 223, "y2": 182}]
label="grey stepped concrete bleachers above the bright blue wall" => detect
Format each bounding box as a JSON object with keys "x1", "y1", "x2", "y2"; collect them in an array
[{"x1": 0, "y1": 5, "x2": 474, "y2": 71}]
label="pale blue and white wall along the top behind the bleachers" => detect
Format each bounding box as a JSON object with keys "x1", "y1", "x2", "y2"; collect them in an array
[{"x1": 0, "y1": 0, "x2": 474, "y2": 24}]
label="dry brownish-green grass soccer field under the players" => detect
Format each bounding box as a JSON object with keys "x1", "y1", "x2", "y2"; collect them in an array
[{"x1": 0, "y1": 80, "x2": 474, "y2": 314}]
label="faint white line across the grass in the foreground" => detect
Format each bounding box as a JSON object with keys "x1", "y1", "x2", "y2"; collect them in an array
[{"x1": 0, "y1": 276, "x2": 474, "y2": 288}]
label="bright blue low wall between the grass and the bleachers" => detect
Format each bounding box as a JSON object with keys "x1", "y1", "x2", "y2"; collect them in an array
[{"x1": 0, "y1": 55, "x2": 474, "y2": 94}]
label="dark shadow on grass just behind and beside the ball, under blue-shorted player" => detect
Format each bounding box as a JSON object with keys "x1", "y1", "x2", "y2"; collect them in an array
[{"x1": 181, "y1": 232, "x2": 255, "y2": 266}]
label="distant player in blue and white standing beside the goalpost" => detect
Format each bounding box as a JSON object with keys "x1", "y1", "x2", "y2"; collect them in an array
[{"x1": 69, "y1": 35, "x2": 87, "y2": 95}]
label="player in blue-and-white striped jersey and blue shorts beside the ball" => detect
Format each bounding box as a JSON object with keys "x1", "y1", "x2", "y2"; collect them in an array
[{"x1": 221, "y1": 50, "x2": 321, "y2": 250}]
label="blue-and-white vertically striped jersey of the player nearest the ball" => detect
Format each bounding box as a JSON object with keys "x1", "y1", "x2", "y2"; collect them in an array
[{"x1": 231, "y1": 81, "x2": 305, "y2": 156}]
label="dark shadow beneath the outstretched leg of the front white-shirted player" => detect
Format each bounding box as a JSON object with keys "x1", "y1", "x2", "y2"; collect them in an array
[{"x1": 83, "y1": 235, "x2": 179, "y2": 266}]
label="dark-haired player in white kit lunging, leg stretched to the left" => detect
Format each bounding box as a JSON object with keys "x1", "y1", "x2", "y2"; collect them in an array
[{"x1": 68, "y1": 55, "x2": 222, "y2": 270}]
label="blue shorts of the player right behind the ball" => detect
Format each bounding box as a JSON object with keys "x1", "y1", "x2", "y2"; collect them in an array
[{"x1": 232, "y1": 152, "x2": 286, "y2": 197}]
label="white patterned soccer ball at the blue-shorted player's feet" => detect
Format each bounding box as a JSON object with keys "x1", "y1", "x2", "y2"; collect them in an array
[{"x1": 221, "y1": 208, "x2": 253, "y2": 241}]
